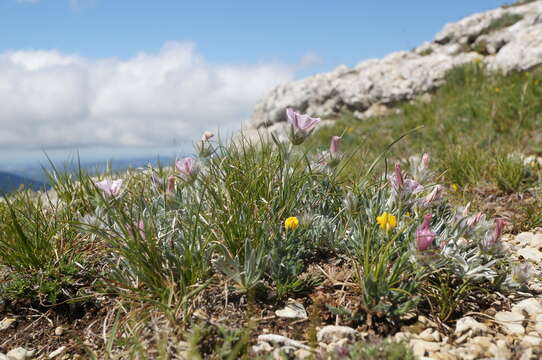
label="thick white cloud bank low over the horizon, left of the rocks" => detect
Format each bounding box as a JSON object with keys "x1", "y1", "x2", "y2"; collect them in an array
[{"x1": 0, "y1": 42, "x2": 298, "y2": 150}]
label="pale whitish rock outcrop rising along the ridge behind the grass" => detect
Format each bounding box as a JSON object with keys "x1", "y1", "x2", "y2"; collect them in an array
[{"x1": 247, "y1": 0, "x2": 542, "y2": 133}]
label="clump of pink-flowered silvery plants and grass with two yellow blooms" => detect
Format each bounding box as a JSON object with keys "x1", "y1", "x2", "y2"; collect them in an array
[{"x1": 0, "y1": 105, "x2": 528, "y2": 356}]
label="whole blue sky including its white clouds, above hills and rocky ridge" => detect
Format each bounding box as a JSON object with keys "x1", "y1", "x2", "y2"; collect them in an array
[{"x1": 0, "y1": 0, "x2": 506, "y2": 169}]
